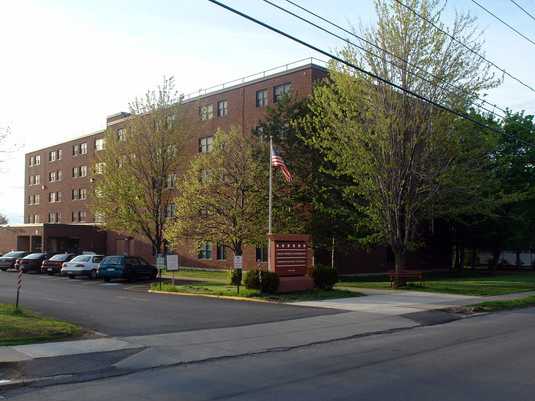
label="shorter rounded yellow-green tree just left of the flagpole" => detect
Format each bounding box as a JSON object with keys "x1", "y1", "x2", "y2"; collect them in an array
[{"x1": 165, "y1": 127, "x2": 268, "y2": 262}]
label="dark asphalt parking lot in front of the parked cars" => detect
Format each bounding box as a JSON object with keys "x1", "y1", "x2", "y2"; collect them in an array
[{"x1": 0, "y1": 272, "x2": 338, "y2": 336}]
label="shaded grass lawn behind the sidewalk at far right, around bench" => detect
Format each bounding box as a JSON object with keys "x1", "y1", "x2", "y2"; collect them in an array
[{"x1": 337, "y1": 272, "x2": 535, "y2": 296}]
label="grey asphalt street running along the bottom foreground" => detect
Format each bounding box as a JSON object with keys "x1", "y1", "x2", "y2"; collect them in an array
[{"x1": 4, "y1": 309, "x2": 535, "y2": 401}]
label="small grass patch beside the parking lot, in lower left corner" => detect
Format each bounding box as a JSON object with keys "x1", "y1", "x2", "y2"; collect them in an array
[{"x1": 0, "y1": 304, "x2": 82, "y2": 346}]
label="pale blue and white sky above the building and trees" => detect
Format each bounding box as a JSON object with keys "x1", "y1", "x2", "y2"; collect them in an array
[{"x1": 0, "y1": 0, "x2": 535, "y2": 223}]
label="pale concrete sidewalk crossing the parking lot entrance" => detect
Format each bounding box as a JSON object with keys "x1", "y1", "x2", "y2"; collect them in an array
[{"x1": 0, "y1": 312, "x2": 419, "y2": 368}]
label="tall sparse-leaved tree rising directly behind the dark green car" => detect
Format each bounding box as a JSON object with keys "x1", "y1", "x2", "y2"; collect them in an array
[{"x1": 90, "y1": 78, "x2": 188, "y2": 253}]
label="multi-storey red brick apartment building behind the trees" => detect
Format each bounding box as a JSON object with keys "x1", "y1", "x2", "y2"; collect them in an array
[{"x1": 0, "y1": 59, "x2": 336, "y2": 267}]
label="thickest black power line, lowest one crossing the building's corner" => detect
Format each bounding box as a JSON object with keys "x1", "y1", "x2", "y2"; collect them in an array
[{"x1": 208, "y1": 0, "x2": 535, "y2": 146}]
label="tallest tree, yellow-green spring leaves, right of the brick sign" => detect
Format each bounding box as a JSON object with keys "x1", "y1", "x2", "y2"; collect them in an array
[{"x1": 309, "y1": 0, "x2": 499, "y2": 276}]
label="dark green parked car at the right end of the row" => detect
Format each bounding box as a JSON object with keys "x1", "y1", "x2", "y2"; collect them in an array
[{"x1": 98, "y1": 256, "x2": 158, "y2": 281}]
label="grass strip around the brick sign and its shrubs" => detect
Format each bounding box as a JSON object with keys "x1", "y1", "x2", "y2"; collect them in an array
[{"x1": 152, "y1": 283, "x2": 361, "y2": 302}]
